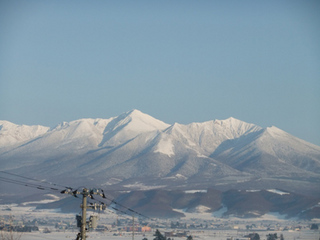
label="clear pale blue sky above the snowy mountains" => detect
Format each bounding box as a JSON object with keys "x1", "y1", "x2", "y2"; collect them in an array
[{"x1": 0, "y1": 0, "x2": 320, "y2": 145}]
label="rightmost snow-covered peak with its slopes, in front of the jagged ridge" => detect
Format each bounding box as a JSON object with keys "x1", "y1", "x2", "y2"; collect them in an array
[{"x1": 211, "y1": 127, "x2": 320, "y2": 177}]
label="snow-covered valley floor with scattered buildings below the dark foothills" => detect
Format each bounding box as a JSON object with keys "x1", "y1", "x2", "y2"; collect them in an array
[{"x1": 0, "y1": 204, "x2": 320, "y2": 240}]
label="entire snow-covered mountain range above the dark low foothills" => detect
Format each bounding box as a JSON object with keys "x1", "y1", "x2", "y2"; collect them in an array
[{"x1": 0, "y1": 110, "x2": 320, "y2": 218}]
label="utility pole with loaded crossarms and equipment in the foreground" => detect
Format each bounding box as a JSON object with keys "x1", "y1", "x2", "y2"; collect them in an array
[{"x1": 61, "y1": 188, "x2": 106, "y2": 240}]
